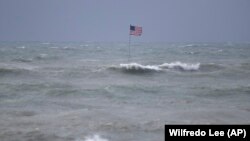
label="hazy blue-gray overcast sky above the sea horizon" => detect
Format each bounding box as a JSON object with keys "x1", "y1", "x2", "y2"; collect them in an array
[{"x1": 0, "y1": 0, "x2": 250, "y2": 42}]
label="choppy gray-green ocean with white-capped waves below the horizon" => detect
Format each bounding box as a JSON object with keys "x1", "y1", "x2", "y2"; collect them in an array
[{"x1": 0, "y1": 42, "x2": 250, "y2": 141}]
